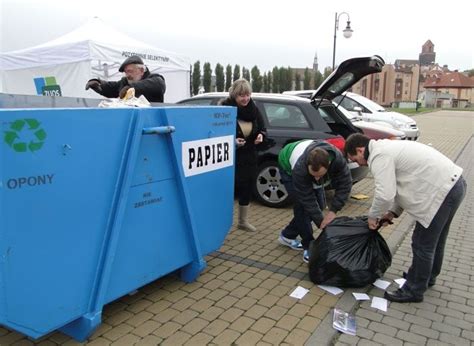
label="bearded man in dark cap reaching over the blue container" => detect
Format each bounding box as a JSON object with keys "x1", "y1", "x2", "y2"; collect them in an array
[{"x1": 86, "y1": 55, "x2": 166, "y2": 102}]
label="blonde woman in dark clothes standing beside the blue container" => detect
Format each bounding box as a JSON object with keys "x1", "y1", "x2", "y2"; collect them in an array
[{"x1": 222, "y1": 79, "x2": 265, "y2": 231}]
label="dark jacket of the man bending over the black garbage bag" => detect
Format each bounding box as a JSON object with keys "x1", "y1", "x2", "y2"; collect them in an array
[{"x1": 291, "y1": 141, "x2": 352, "y2": 227}]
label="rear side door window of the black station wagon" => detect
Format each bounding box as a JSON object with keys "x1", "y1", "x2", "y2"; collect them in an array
[{"x1": 262, "y1": 102, "x2": 310, "y2": 129}]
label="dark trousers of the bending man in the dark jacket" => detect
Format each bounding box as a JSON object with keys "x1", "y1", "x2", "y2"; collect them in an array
[{"x1": 280, "y1": 169, "x2": 326, "y2": 250}]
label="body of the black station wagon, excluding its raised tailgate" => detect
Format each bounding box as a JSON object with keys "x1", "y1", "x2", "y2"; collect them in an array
[{"x1": 178, "y1": 92, "x2": 367, "y2": 207}]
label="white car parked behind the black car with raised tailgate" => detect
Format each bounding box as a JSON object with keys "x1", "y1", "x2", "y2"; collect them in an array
[{"x1": 283, "y1": 90, "x2": 420, "y2": 141}]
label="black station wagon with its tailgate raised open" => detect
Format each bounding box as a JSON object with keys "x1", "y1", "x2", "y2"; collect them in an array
[{"x1": 178, "y1": 56, "x2": 384, "y2": 207}]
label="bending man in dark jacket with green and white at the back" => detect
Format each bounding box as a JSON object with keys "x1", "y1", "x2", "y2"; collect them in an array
[{"x1": 278, "y1": 140, "x2": 352, "y2": 263}]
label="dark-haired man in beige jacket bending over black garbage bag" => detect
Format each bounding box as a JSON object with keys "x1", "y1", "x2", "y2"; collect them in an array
[{"x1": 345, "y1": 134, "x2": 466, "y2": 303}]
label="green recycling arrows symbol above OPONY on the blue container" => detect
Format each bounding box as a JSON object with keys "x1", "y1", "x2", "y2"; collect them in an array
[{"x1": 4, "y1": 119, "x2": 47, "y2": 153}]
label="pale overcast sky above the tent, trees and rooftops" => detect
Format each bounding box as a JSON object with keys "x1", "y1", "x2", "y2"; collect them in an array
[{"x1": 0, "y1": 0, "x2": 474, "y2": 73}]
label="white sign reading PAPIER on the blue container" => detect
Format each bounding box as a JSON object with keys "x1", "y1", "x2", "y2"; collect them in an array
[{"x1": 181, "y1": 136, "x2": 234, "y2": 177}]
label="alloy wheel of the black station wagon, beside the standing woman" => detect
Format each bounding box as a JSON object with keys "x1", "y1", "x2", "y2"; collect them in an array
[{"x1": 254, "y1": 161, "x2": 290, "y2": 208}]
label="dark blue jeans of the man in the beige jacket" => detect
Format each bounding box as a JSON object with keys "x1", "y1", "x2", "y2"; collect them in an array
[{"x1": 403, "y1": 176, "x2": 466, "y2": 297}]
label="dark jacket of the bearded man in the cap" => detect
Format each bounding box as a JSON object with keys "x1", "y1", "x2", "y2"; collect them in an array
[{"x1": 96, "y1": 69, "x2": 166, "y2": 102}]
